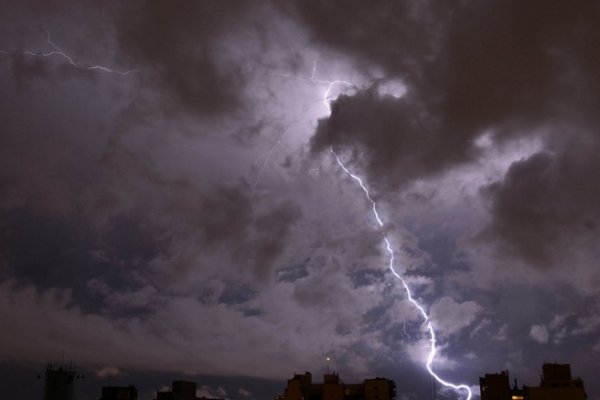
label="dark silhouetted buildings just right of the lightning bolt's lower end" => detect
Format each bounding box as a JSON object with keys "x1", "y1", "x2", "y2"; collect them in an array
[{"x1": 479, "y1": 364, "x2": 587, "y2": 400}]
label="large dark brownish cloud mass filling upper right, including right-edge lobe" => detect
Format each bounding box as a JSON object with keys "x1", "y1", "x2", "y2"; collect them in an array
[{"x1": 288, "y1": 1, "x2": 600, "y2": 290}]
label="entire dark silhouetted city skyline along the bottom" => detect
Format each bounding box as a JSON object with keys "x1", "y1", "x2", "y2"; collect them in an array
[{"x1": 25, "y1": 360, "x2": 588, "y2": 400}]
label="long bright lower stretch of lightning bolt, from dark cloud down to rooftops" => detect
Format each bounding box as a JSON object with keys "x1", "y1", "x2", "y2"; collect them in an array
[{"x1": 330, "y1": 147, "x2": 472, "y2": 400}]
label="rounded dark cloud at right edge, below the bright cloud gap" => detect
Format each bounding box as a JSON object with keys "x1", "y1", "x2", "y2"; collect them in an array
[{"x1": 483, "y1": 132, "x2": 600, "y2": 268}]
